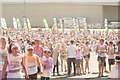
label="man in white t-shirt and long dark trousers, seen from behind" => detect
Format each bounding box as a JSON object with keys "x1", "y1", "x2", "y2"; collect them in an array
[{"x1": 67, "y1": 40, "x2": 77, "y2": 76}]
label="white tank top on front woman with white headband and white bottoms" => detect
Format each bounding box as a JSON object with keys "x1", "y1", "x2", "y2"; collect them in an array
[{"x1": 7, "y1": 54, "x2": 23, "y2": 70}]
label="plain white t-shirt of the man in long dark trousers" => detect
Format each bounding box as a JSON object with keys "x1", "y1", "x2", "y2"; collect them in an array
[{"x1": 67, "y1": 45, "x2": 77, "y2": 58}]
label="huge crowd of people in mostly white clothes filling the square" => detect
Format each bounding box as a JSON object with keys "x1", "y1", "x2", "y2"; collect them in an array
[{"x1": 0, "y1": 29, "x2": 120, "y2": 80}]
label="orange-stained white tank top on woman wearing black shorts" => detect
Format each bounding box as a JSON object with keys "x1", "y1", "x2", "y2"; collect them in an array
[{"x1": 26, "y1": 54, "x2": 38, "y2": 75}]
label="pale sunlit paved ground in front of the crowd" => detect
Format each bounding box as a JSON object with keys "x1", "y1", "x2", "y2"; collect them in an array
[{"x1": 51, "y1": 53, "x2": 112, "y2": 80}]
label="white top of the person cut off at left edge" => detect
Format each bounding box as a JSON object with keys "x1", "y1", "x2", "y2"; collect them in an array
[{"x1": 0, "y1": 48, "x2": 8, "y2": 71}]
